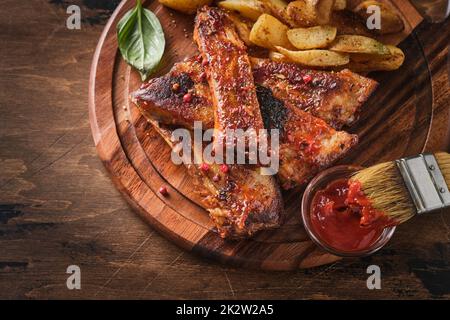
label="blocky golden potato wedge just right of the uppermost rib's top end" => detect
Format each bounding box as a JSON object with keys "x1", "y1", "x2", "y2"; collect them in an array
[{"x1": 250, "y1": 13, "x2": 293, "y2": 50}]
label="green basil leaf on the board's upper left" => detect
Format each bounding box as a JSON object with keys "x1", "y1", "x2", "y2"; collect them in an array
[{"x1": 117, "y1": 0, "x2": 166, "y2": 81}]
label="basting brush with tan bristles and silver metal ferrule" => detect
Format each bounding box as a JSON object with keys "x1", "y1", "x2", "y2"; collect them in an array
[{"x1": 350, "y1": 152, "x2": 450, "y2": 224}]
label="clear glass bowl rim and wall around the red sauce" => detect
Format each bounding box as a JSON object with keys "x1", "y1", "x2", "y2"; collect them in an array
[{"x1": 301, "y1": 165, "x2": 395, "y2": 257}]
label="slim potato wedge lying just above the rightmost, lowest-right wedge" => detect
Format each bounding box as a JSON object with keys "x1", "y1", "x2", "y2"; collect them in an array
[{"x1": 328, "y1": 35, "x2": 389, "y2": 55}]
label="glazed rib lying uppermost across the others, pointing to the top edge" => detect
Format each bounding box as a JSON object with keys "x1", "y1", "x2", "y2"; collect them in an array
[{"x1": 194, "y1": 6, "x2": 264, "y2": 148}]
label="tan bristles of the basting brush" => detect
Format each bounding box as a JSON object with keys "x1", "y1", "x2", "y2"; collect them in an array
[{"x1": 351, "y1": 161, "x2": 416, "y2": 223}]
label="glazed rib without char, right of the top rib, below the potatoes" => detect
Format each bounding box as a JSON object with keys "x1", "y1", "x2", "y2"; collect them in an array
[{"x1": 252, "y1": 58, "x2": 377, "y2": 129}]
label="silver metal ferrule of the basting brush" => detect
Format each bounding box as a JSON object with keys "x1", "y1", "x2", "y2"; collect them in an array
[{"x1": 396, "y1": 154, "x2": 450, "y2": 214}]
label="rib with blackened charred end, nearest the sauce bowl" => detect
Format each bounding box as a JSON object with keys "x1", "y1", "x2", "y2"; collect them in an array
[{"x1": 258, "y1": 86, "x2": 358, "y2": 189}]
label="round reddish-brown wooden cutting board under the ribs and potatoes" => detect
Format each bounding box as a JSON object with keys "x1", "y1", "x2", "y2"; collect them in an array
[{"x1": 89, "y1": 0, "x2": 449, "y2": 270}]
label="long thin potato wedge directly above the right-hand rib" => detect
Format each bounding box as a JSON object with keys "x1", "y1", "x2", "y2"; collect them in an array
[{"x1": 277, "y1": 47, "x2": 350, "y2": 67}]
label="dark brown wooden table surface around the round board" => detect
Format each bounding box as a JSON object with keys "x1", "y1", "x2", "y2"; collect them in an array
[{"x1": 0, "y1": 0, "x2": 450, "y2": 299}]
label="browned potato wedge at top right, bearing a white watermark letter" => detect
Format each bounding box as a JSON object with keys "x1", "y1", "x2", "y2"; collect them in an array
[{"x1": 353, "y1": 1, "x2": 405, "y2": 34}]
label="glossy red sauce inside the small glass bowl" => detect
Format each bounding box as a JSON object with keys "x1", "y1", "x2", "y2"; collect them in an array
[{"x1": 311, "y1": 179, "x2": 394, "y2": 252}]
